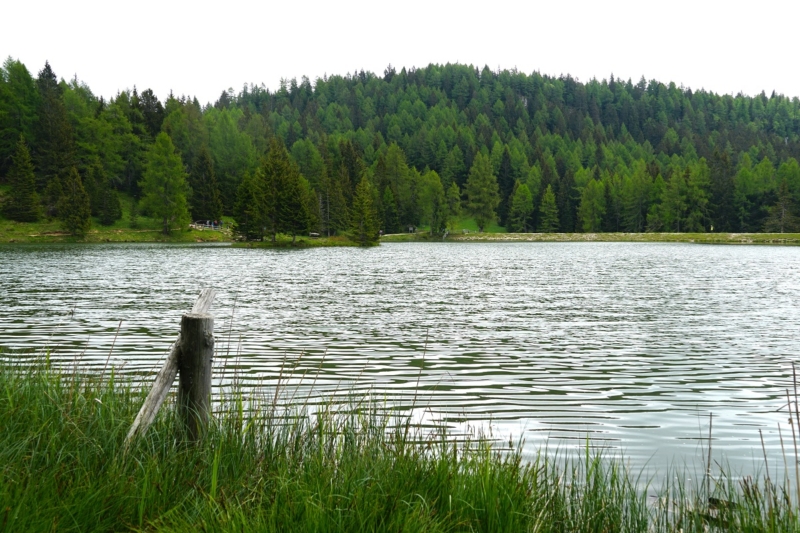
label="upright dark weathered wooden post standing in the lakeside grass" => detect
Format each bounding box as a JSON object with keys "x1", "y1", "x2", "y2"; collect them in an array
[{"x1": 178, "y1": 313, "x2": 214, "y2": 441}]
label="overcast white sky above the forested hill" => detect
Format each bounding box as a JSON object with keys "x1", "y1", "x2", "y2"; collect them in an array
[{"x1": 0, "y1": 0, "x2": 800, "y2": 103}]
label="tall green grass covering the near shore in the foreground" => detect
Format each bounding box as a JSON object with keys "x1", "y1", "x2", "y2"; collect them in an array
[{"x1": 0, "y1": 362, "x2": 800, "y2": 532}]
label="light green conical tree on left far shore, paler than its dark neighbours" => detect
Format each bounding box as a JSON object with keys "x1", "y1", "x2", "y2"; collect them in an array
[{"x1": 139, "y1": 132, "x2": 189, "y2": 235}]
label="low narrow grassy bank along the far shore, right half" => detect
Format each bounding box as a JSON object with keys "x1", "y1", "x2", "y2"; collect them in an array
[{"x1": 381, "y1": 231, "x2": 800, "y2": 245}]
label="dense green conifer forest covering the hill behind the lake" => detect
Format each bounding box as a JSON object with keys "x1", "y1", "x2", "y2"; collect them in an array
[{"x1": 0, "y1": 58, "x2": 800, "y2": 240}]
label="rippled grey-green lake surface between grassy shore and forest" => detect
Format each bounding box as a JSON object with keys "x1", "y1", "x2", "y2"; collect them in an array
[{"x1": 0, "y1": 243, "x2": 800, "y2": 471}]
